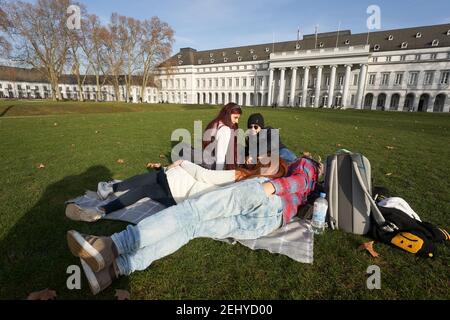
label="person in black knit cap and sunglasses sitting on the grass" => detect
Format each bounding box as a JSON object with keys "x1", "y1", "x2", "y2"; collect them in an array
[{"x1": 245, "y1": 113, "x2": 297, "y2": 164}]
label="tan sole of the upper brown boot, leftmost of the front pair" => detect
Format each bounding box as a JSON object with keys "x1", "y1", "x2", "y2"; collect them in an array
[{"x1": 67, "y1": 230, "x2": 105, "y2": 272}]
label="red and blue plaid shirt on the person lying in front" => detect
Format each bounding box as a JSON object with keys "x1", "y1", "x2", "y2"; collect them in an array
[{"x1": 270, "y1": 158, "x2": 318, "y2": 225}]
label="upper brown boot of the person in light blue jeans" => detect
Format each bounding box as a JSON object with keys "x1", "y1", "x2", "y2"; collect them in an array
[{"x1": 67, "y1": 230, "x2": 118, "y2": 272}]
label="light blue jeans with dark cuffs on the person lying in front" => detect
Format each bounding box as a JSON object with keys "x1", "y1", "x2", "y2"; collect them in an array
[{"x1": 111, "y1": 178, "x2": 283, "y2": 275}]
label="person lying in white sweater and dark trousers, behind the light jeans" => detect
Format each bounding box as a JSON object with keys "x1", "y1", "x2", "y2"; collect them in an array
[{"x1": 66, "y1": 159, "x2": 287, "y2": 222}]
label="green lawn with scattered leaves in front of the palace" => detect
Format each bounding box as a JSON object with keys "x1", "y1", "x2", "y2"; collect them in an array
[{"x1": 0, "y1": 101, "x2": 450, "y2": 299}]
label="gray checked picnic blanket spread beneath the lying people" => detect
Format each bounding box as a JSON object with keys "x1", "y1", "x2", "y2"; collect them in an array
[{"x1": 66, "y1": 191, "x2": 314, "y2": 263}]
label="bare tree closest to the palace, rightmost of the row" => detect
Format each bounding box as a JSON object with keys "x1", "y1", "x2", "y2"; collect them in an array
[{"x1": 139, "y1": 17, "x2": 174, "y2": 102}]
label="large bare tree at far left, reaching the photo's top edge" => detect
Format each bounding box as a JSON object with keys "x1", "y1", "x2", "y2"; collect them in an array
[{"x1": 4, "y1": 0, "x2": 72, "y2": 100}]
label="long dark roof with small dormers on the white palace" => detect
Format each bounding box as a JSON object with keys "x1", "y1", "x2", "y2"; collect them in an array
[{"x1": 168, "y1": 23, "x2": 450, "y2": 66}]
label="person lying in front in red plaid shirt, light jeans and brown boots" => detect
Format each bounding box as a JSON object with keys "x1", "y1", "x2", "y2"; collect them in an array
[{"x1": 67, "y1": 158, "x2": 322, "y2": 294}]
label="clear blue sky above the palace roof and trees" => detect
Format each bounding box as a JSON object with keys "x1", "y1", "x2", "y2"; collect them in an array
[{"x1": 80, "y1": 0, "x2": 450, "y2": 53}]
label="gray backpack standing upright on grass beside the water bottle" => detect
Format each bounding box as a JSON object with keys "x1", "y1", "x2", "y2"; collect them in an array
[{"x1": 324, "y1": 150, "x2": 391, "y2": 235}]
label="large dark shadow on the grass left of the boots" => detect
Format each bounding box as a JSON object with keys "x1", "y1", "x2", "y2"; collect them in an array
[{"x1": 0, "y1": 166, "x2": 129, "y2": 299}]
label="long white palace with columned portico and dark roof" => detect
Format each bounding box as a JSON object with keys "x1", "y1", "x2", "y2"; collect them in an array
[{"x1": 0, "y1": 24, "x2": 450, "y2": 112}]
